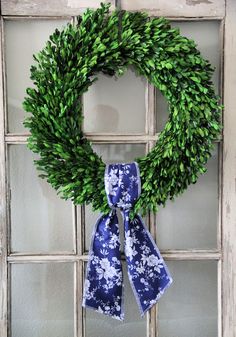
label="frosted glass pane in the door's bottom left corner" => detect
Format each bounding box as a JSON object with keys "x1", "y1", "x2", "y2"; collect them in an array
[{"x1": 11, "y1": 263, "x2": 74, "y2": 337}]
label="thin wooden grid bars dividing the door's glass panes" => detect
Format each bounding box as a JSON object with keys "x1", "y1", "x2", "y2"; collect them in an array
[{"x1": 2, "y1": 8, "x2": 226, "y2": 337}]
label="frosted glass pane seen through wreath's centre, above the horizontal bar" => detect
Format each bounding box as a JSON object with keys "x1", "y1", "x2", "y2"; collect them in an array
[{"x1": 84, "y1": 69, "x2": 146, "y2": 133}]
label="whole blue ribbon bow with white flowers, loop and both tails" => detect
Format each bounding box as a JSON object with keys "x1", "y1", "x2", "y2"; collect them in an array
[{"x1": 83, "y1": 162, "x2": 172, "y2": 320}]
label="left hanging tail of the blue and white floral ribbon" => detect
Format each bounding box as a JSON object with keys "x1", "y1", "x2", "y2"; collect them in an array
[{"x1": 83, "y1": 211, "x2": 124, "y2": 320}]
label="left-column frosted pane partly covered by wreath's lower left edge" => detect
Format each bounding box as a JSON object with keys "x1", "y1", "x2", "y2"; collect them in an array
[{"x1": 9, "y1": 145, "x2": 73, "y2": 252}]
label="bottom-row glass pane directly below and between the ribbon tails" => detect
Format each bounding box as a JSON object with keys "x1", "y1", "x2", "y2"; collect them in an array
[{"x1": 85, "y1": 263, "x2": 147, "y2": 337}]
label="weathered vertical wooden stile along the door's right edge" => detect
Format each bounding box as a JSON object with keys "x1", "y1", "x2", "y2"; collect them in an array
[{"x1": 222, "y1": 0, "x2": 236, "y2": 337}]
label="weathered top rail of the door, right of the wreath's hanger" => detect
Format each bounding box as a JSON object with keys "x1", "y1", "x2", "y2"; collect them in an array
[{"x1": 120, "y1": 0, "x2": 225, "y2": 18}]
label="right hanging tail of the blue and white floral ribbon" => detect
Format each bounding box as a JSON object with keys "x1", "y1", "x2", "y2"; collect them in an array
[{"x1": 124, "y1": 211, "x2": 172, "y2": 316}]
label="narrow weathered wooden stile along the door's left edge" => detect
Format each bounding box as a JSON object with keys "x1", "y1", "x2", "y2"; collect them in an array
[{"x1": 0, "y1": 19, "x2": 7, "y2": 337}]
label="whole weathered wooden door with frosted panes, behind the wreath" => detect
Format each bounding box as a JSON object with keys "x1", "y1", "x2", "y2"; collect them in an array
[{"x1": 0, "y1": 0, "x2": 236, "y2": 337}]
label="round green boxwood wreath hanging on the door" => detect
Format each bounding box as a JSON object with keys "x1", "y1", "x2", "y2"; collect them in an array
[{"x1": 23, "y1": 4, "x2": 221, "y2": 214}]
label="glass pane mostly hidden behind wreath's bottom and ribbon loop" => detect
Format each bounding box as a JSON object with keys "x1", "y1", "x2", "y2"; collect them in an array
[{"x1": 85, "y1": 144, "x2": 145, "y2": 250}]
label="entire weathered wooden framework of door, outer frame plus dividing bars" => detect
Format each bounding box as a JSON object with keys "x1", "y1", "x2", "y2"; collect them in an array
[{"x1": 0, "y1": 0, "x2": 236, "y2": 337}]
